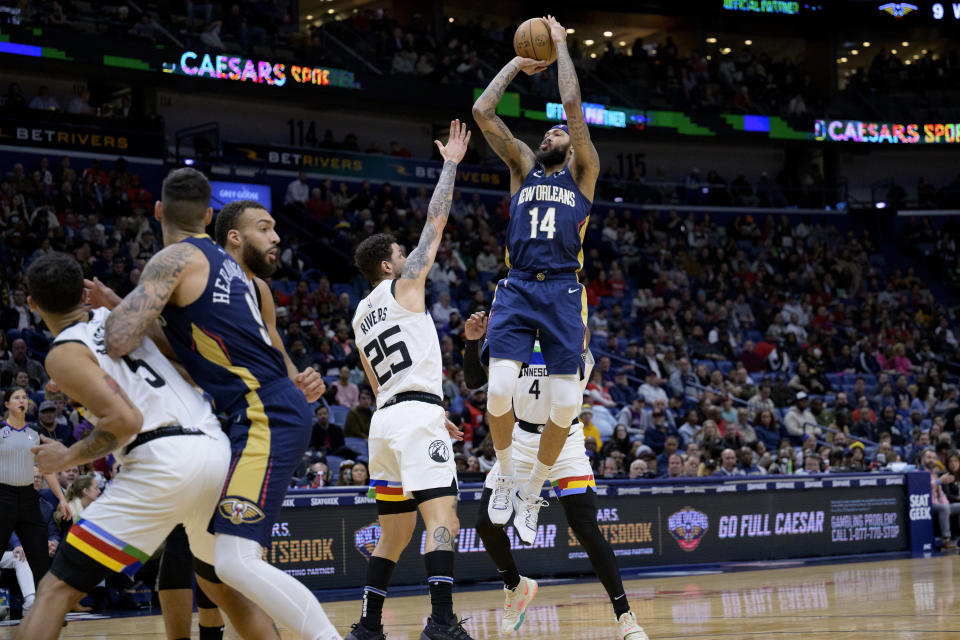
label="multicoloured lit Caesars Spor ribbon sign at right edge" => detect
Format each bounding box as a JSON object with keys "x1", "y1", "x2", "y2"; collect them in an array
[{"x1": 814, "y1": 120, "x2": 960, "y2": 144}]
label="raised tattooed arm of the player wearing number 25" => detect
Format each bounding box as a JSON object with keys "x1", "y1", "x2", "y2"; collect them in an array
[{"x1": 394, "y1": 120, "x2": 470, "y2": 312}]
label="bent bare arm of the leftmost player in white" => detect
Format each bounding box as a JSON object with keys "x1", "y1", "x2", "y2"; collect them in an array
[{"x1": 33, "y1": 342, "x2": 143, "y2": 473}]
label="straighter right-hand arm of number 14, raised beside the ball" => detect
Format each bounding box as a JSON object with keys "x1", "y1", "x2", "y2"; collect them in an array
[{"x1": 544, "y1": 16, "x2": 600, "y2": 201}]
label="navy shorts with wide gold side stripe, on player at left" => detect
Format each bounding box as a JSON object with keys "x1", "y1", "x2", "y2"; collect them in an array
[{"x1": 210, "y1": 378, "x2": 313, "y2": 547}]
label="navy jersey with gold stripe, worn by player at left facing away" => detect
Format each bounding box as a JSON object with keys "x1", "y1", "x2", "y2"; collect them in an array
[{"x1": 163, "y1": 235, "x2": 287, "y2": 414}]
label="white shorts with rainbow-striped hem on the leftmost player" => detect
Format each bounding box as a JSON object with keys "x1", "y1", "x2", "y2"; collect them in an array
[{"x1": 67, "y1": 431, "x2": 230, "y2": 575}]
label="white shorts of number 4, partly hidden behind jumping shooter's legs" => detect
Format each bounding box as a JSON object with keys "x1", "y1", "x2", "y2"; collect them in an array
[{"x1": 484, "y1": 423, "x2": 597, "y2": 498}]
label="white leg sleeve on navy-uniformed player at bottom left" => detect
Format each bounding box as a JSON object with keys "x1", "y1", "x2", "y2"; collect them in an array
[{"x1": 214, "y1": 533, "x2": 342, "y2": 640}]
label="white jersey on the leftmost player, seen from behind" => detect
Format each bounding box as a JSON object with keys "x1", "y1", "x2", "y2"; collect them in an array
[{"x1": 54, "y1": 309, "x2": 220, "y2": 444}]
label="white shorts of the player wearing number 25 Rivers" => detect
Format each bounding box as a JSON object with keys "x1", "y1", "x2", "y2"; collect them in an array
[{"x1": 368, "y1": 401, "x2": 457, "y2": 502}]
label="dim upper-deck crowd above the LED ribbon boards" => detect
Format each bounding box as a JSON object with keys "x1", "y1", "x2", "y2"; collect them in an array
[{"x1": 3, "y1": 0, "x2": 840, "y2": 116}]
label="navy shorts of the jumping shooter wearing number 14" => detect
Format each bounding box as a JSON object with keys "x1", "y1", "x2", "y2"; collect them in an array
[{"x1": 487, "y1": 273, "x2": 587, "y2": 375}]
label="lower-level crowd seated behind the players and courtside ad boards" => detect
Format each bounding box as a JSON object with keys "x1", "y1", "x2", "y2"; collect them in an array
[{"x1": 0, "y1": 138, "x2": 960, "y2": 572}]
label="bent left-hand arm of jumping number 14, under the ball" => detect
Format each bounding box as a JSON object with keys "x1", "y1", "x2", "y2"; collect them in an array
[{"x1": 473, "y1": 56, "x2": 547, "y2": 193}]
